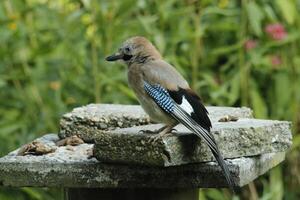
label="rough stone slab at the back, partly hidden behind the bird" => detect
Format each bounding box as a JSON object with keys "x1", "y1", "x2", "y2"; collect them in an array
[{"x1": 59, "y1": 104, "x2": 252, "y2": 142}]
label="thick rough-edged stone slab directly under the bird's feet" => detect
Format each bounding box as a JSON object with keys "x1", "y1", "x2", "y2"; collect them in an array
[{"x1": 94, "y1": 119, "x2": 292, "y2": 166}]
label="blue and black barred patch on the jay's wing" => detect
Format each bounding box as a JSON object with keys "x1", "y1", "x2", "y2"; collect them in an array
[{"x1": 144, "y1": 81, "x2": 175, "y2": 113}]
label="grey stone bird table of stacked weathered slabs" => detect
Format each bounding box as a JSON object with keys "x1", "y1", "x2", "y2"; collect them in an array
[{"x1": 0, "y1": 104, "x2": 292, "y2": 200}]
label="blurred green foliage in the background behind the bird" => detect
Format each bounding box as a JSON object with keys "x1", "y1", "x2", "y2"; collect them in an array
[{"x1": 0, "y1": 0, "x2": 300, "y2": 200}]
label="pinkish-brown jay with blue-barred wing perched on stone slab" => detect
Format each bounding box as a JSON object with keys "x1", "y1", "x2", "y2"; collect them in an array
[{"x1": 106, "y1": 36, "x2": 236, "y2": 191}]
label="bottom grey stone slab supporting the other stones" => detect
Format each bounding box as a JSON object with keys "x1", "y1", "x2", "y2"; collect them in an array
[{"x1": 0, "y1": 134, "x2": 285, "y2": 188}]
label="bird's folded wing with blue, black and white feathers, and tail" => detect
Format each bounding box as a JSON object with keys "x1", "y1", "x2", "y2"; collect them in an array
[{"x1": 144, "y1": 65, "x2": 236, "y2": 191}]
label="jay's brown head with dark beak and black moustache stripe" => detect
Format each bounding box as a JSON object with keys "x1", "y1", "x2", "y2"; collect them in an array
[{"x1": 106, "y1": 36, "x2": 161, "y2": 65}]
